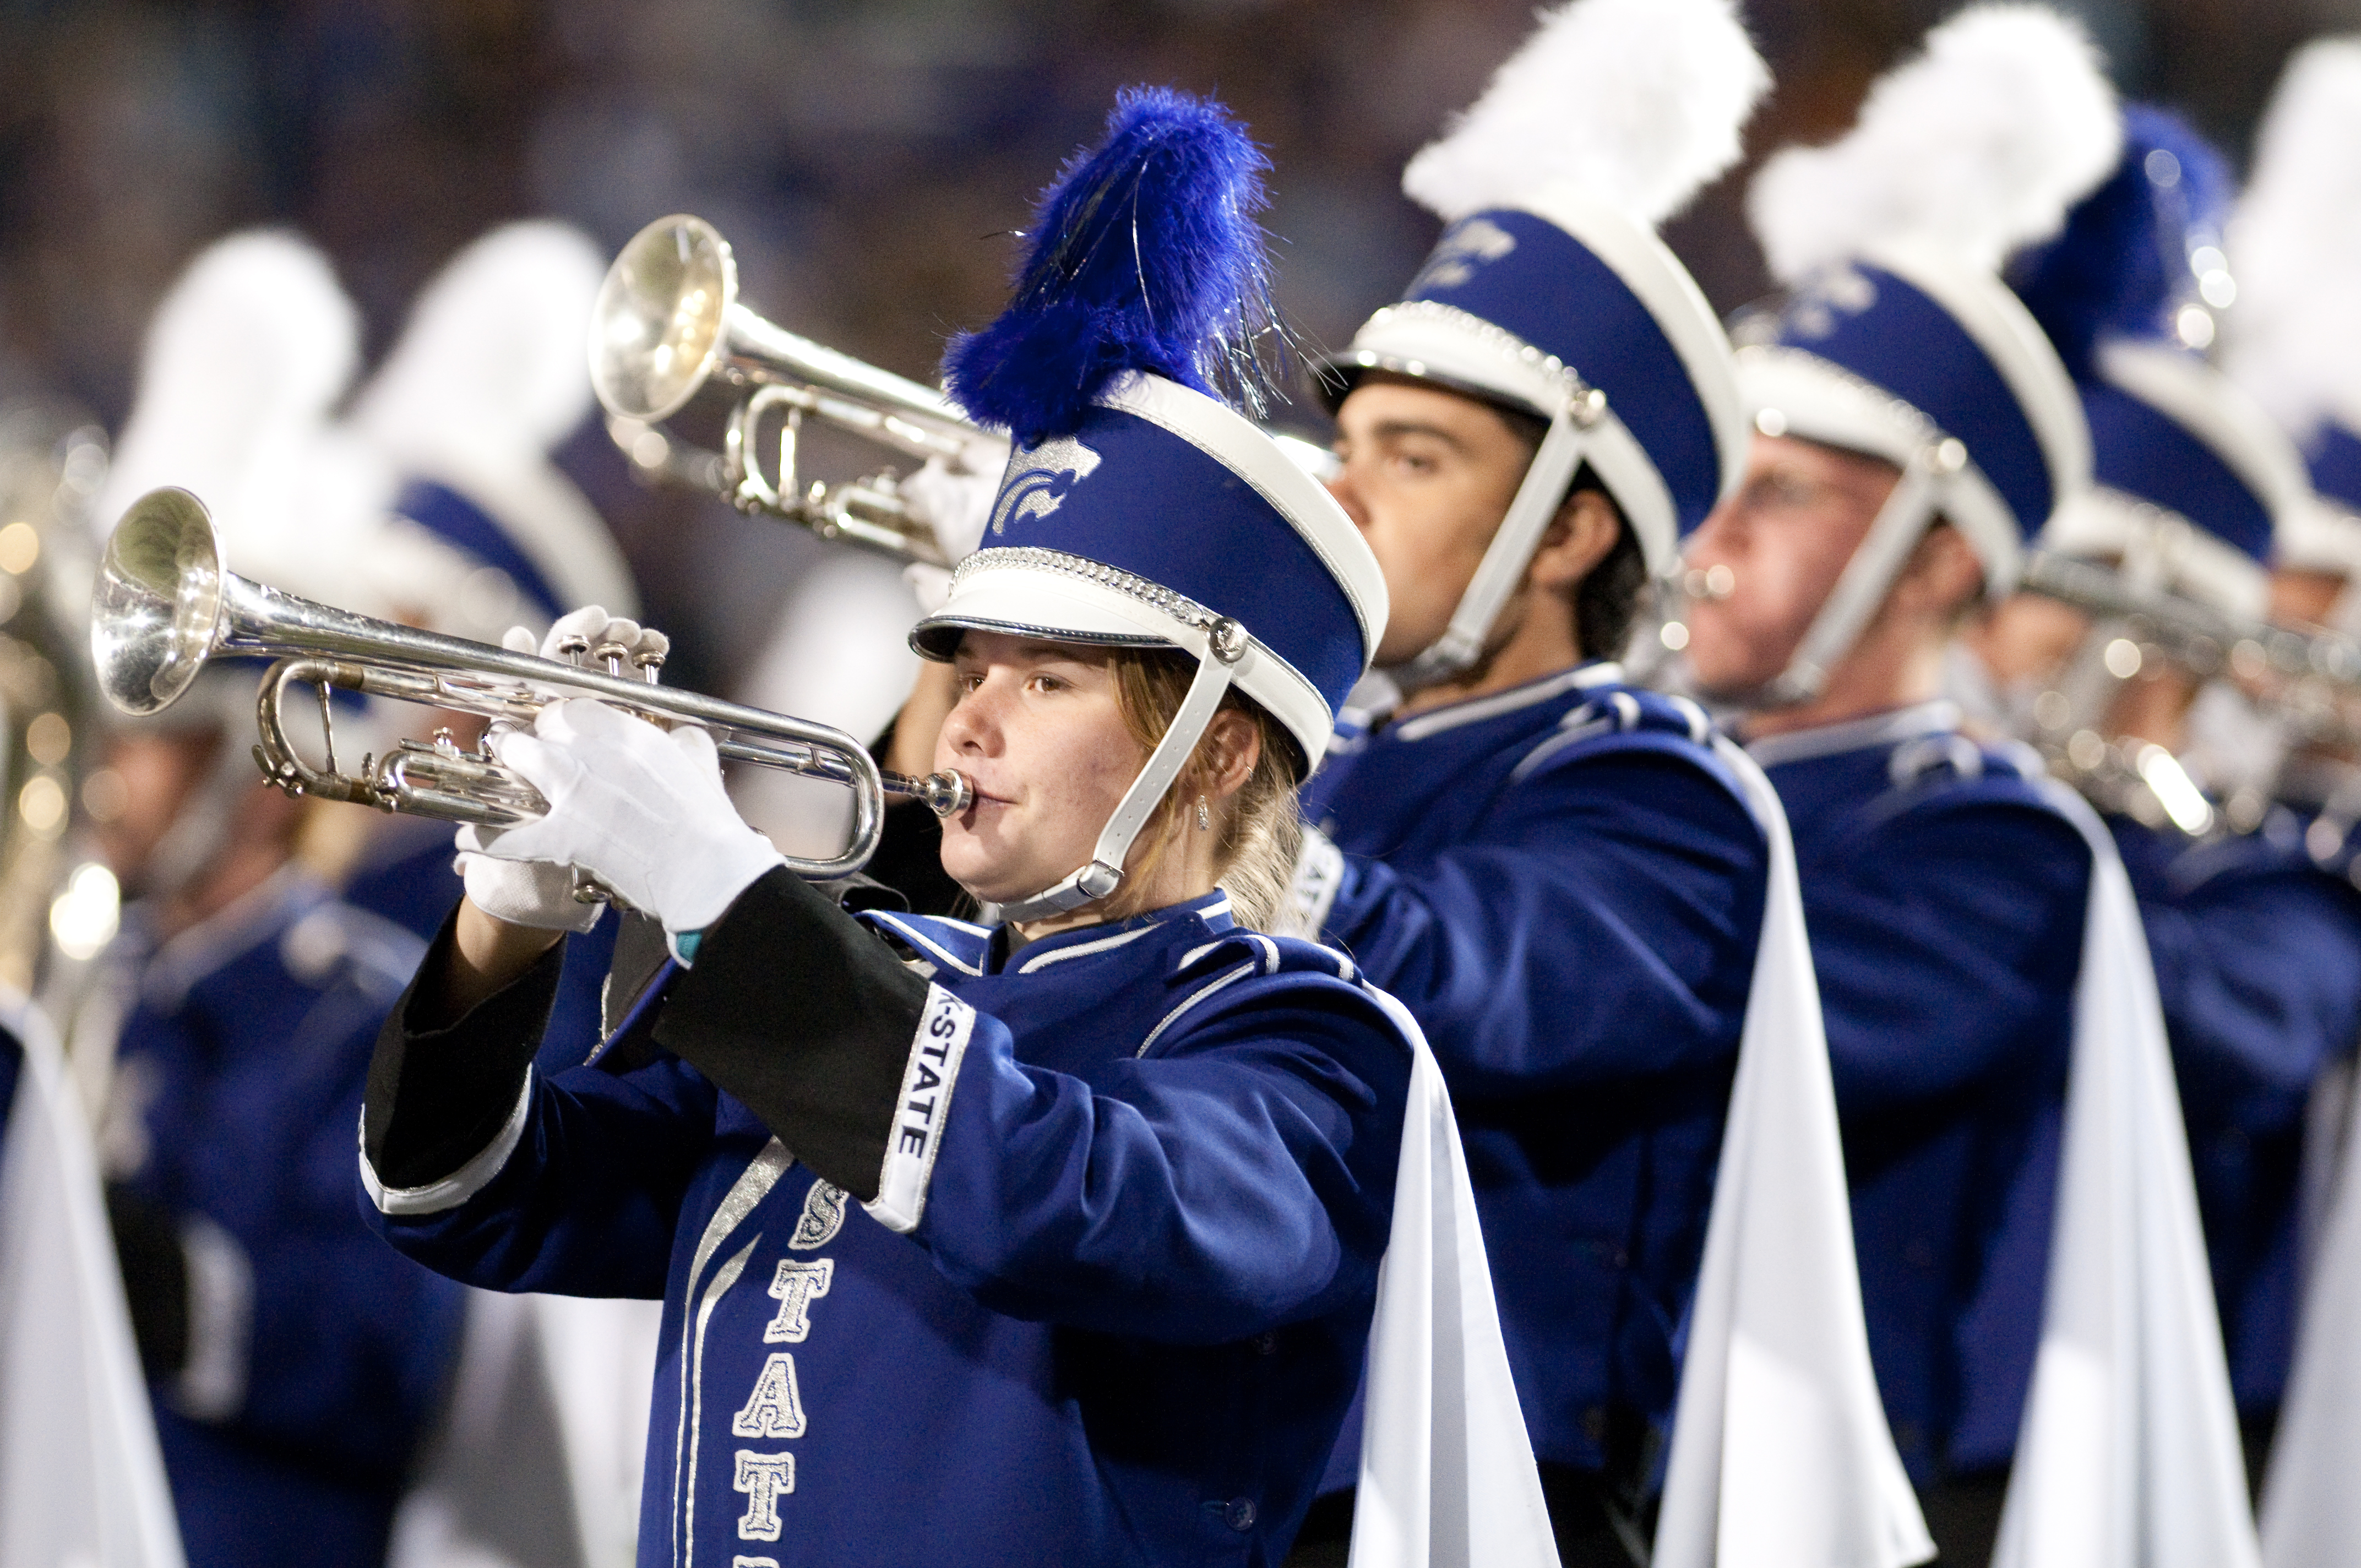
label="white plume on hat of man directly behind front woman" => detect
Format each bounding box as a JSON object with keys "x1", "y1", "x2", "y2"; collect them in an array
[{"x1": 1402, "y1": 0, "x2": 1771, "y2": 227}]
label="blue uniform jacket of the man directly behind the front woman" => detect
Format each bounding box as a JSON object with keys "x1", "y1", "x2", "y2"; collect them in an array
[{"x1": 1305, "y1": 663, "x2": 1769, "y2": 1485}]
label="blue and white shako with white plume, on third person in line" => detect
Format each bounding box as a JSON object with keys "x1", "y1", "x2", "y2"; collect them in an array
[{"x1": 1738, "y1": 5, "x2": 2123, "y2": 701}]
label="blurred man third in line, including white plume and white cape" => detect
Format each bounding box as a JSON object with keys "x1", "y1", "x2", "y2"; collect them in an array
[{"x1": 1686, "y1": 5, "x2": 2253, "y2": 1563}]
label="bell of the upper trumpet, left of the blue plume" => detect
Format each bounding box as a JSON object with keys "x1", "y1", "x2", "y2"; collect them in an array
[{"x1": 590, "y1": 213, "x2": 737, "y2": 425}]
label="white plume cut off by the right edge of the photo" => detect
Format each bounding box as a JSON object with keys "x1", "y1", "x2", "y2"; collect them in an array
[{"x1": 2224, "y1": 38, "x2": 2361, "y2": 434}]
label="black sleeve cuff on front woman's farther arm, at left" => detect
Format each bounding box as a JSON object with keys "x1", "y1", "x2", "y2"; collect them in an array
[{"x1": 361, "y1": 912, "x2": 567, "y2": 1188}]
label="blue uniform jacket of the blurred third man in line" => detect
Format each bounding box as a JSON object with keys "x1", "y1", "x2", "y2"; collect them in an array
[{"x1": 1749, "y1": 704, "x2": 2090, "y2": 1485}]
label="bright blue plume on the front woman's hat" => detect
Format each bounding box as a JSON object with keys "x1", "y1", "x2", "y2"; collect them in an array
[{"x1": 942, "y1": 88, "x2": 1277, "y2": 447}]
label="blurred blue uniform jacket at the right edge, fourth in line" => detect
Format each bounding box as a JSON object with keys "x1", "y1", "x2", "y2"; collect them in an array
[{"x1": 2108, "y1": 808, "x2": 2361, "y2": 1414}]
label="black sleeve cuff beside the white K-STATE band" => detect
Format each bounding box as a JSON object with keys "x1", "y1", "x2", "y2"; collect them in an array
[{"x1": 656, "y1": 869, "x2": 928, "y2": 1202}]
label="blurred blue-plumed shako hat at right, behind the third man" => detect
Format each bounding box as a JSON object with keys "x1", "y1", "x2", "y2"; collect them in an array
[{"x1": 2009, "y1": 104, "x2": 2309, "y2": 619}]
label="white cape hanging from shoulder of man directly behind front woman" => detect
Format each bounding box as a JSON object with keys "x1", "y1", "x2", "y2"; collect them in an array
[{"x1": 1653, "y1": 739, "x2": 1934, "y2": 1568}]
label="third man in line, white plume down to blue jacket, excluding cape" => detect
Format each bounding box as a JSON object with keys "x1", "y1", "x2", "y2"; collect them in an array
[{"x1": 1688, "y1": 7, "x2": 2118, "y2": 1561}]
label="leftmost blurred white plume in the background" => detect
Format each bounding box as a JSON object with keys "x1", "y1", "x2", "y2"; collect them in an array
[{"x1": 92, "y1": 231, "x2": 361, "y2": 546}]
